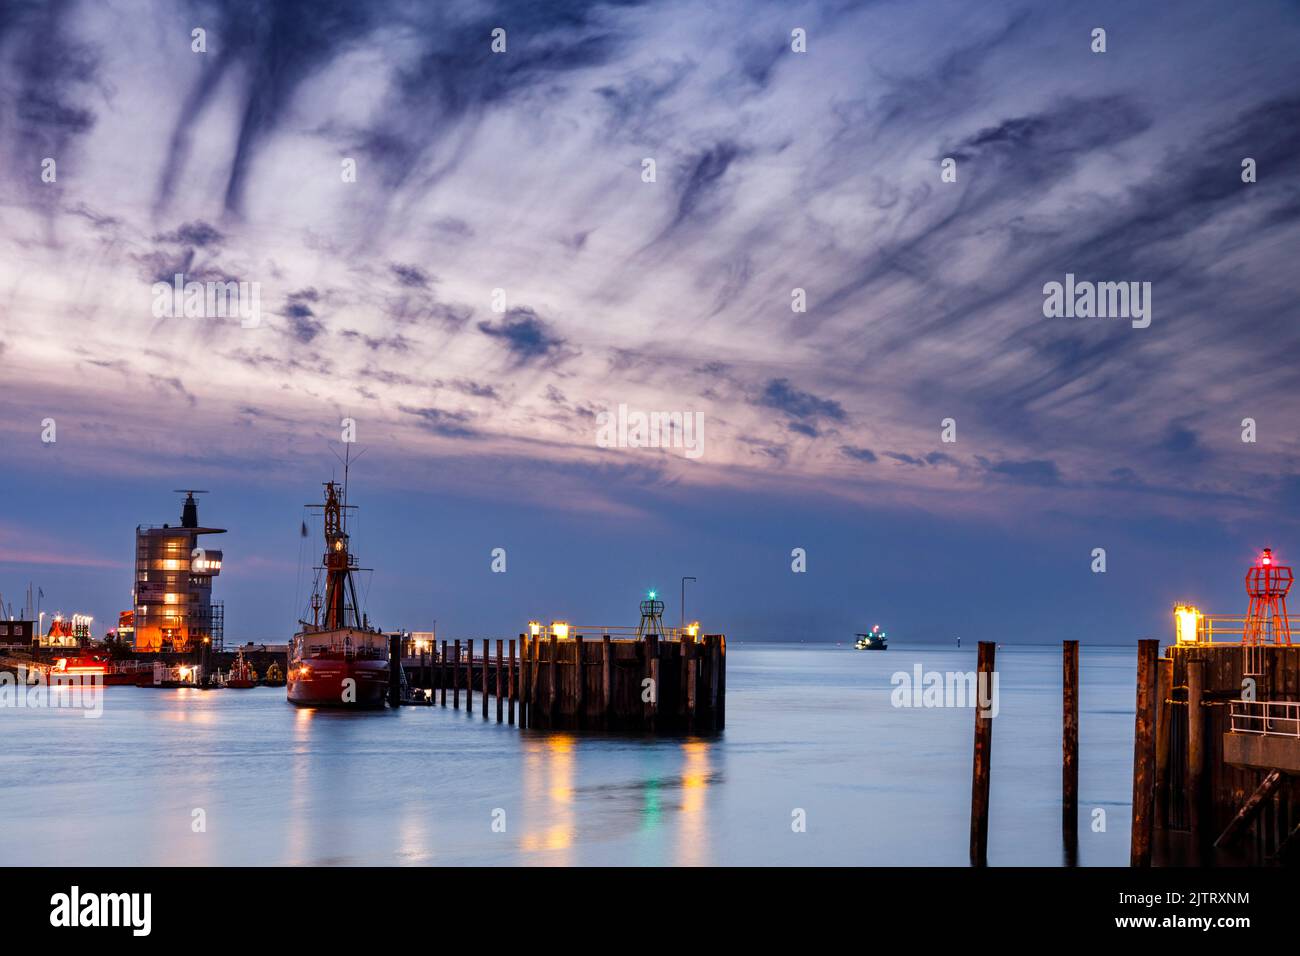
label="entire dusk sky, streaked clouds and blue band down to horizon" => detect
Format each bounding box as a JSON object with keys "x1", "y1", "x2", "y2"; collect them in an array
[{"x1": 0, "y1": 0, "x2": 1300, "y2": 641}]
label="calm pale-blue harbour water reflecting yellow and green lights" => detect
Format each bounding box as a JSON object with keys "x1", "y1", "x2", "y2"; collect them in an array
[{"x1": 0, "y1": 641, "x2": 1136, "y2": 865}]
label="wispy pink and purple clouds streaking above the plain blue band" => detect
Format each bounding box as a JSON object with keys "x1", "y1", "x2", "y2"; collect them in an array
[{"x1": 0, "y1": 0, "x2": 1300, "y2": 530}]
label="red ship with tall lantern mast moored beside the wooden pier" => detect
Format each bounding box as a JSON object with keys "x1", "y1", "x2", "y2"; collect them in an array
[{"x1": 286, "y1": 472, "x2": 389, "y2": 709}]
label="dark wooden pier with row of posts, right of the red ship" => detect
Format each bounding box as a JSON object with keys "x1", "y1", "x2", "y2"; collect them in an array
[{"x1": 390, "y1": 628, "x2": 727, "y2": 734}]
